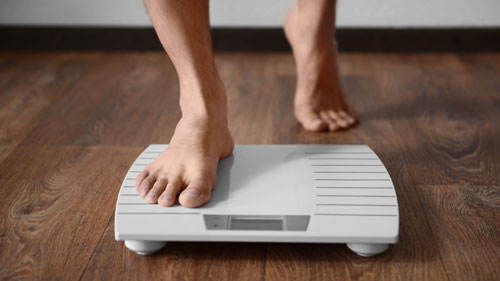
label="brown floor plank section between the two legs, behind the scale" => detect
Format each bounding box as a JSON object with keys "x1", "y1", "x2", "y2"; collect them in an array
[{"x1": 216, "y1": 53, "x2": 277, "y2": 144}]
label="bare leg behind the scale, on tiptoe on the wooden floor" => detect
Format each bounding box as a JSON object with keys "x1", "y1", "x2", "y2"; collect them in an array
[{"x1": 285, "y1": 0, "x2": 356, "y2": 131}]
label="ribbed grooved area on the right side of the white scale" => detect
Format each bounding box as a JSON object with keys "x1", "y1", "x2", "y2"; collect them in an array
[{"x1": 305, "y1": 151, "x2": 398, "y2": 217}]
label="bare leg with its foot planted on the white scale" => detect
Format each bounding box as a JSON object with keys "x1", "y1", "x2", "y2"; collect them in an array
[{"x1": 136, "y1": 0, "x2": 234, "y2": 207}]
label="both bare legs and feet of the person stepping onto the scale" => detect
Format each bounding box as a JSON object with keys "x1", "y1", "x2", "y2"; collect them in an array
[{"x1": 136, "y1": 0, "x2": 356, "y2": 208}]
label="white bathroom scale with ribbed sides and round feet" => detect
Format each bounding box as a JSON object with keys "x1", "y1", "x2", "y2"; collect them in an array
[{"x1": 115, "y1": 144, "x2": 399, "y2": 256}]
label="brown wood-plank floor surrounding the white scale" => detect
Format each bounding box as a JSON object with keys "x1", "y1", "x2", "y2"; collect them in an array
[{"x1": 0, "y1": 52, "x2": 500, "y2": 281}]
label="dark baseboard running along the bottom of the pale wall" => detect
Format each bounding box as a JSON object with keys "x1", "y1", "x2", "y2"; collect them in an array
[{"x1": 0, "y1": 26, "x2": 500, "y2": 52}]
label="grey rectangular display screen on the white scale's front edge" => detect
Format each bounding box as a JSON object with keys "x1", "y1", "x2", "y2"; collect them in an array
[{"x1": 203, "y1": 215, "x2": 310, "y2": 231}]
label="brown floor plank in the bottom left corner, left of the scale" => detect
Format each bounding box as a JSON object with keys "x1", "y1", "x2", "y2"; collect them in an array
[{"x1": 0, "y1": 146, "x2": 140, "y2": 280}]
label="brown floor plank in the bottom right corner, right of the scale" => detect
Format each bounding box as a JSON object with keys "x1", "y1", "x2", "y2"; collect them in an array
[{"x1": 418, "y1": 185, "x2": 500, "y2": 280}]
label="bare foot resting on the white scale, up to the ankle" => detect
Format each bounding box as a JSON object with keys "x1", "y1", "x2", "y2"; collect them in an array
[{"x1": 136, "y1": 83, "x2": 234, "y2": 208}]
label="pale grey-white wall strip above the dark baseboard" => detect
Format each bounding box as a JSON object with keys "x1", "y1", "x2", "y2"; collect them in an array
[{"x1": 0, "y1": 0, "x2": 500, "y2": 27}]
